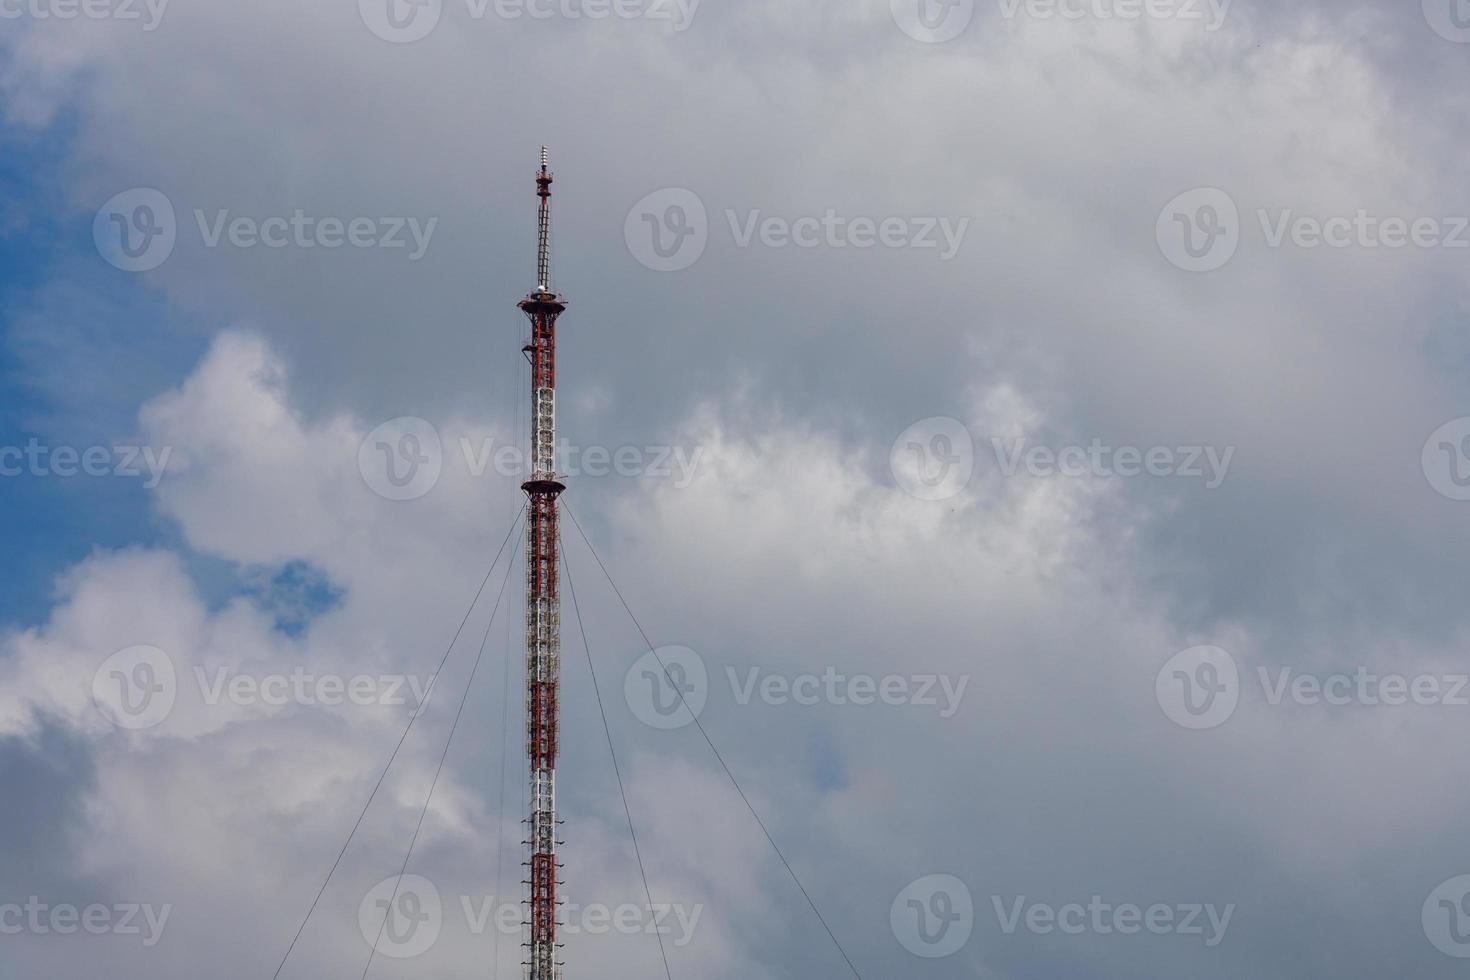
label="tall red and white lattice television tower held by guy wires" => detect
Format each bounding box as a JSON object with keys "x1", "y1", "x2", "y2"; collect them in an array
[{"x1": 519, "y1": 147, "x2": 566, "y2": 980}]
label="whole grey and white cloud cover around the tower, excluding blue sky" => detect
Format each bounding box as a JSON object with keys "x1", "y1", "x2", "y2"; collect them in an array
[{"x1": 0, "y1": 0, "x2": 1470, "y2": 977}]
